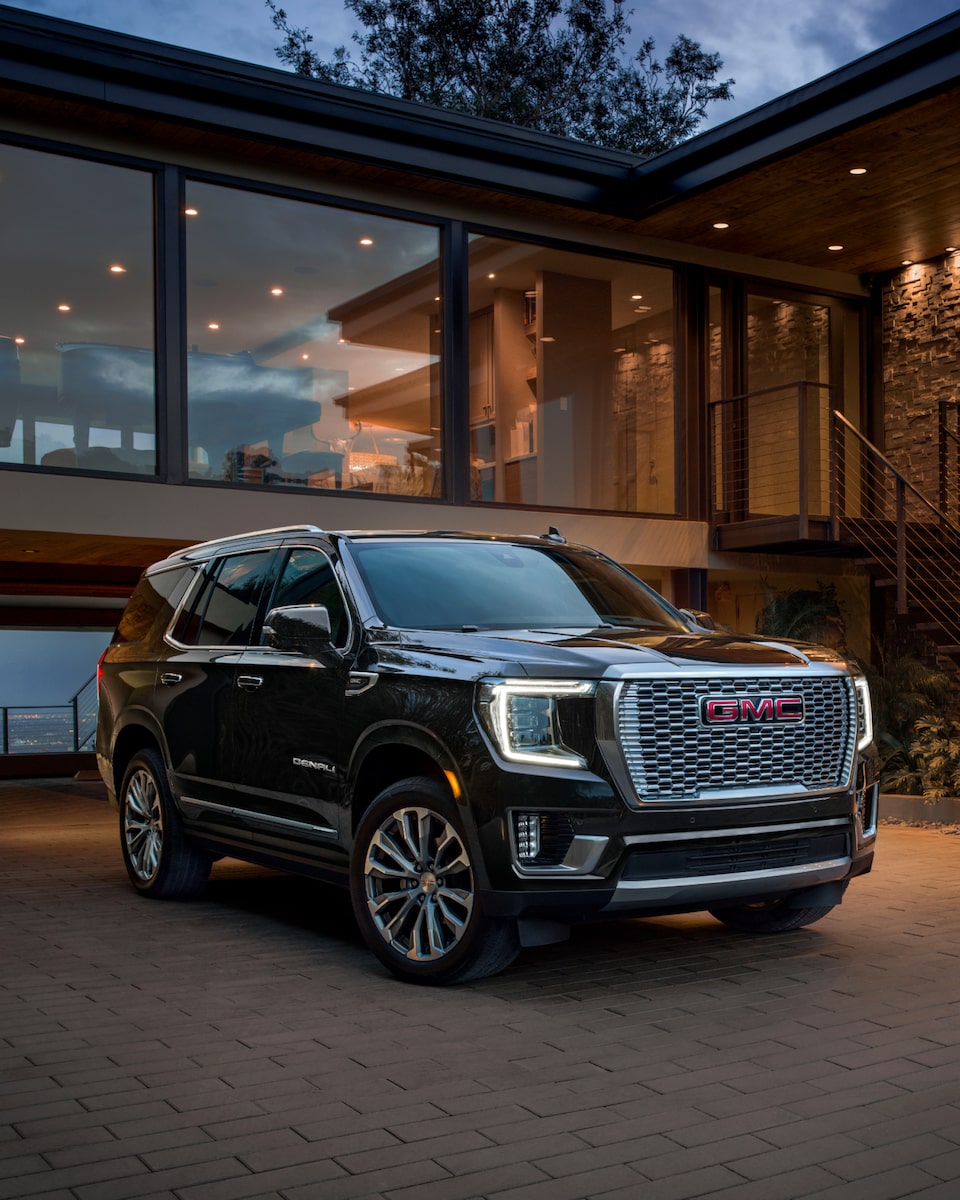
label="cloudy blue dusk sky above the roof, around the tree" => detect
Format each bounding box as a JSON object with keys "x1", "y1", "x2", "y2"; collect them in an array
[{"x1": 12, "y1": 0, "x2": 955, "y2": 124}]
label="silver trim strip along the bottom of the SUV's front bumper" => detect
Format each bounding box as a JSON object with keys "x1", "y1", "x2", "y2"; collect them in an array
[{"x1": 600, "y1": 856, "x2": 851, "y2": 913}]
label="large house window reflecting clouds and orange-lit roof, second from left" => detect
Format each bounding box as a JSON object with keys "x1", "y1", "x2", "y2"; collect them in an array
[{"x1": 187, "y1": 184, "x2": 440, "y2": 496}]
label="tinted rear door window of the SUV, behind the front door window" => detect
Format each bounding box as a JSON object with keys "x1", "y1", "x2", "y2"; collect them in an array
[{"x1": 174, "y1": 550, "x2": 272, "y2": 646}]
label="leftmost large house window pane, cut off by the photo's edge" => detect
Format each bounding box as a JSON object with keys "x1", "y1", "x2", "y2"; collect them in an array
[{"x1": 0, "y1": 145, "x2": 156, "y2": 474}]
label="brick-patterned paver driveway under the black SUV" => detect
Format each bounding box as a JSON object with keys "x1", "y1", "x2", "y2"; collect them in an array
[{"x1": 0, "y1": 780, "x2": 960, "y2": 1200}]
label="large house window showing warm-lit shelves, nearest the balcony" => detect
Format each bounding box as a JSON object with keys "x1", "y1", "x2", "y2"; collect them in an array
[{"x1": 469, "y1": 236, "x2": 676, "y2": 512}]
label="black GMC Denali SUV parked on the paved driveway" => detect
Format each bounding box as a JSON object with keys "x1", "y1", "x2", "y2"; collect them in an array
[{"x1": 97, "y1": 526, "x2": 877, "y2": 984}]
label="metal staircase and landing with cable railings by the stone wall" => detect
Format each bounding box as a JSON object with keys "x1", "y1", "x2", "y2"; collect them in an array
[{"x1": 709, "y1": 380, "x2": 960, "y2": 677}]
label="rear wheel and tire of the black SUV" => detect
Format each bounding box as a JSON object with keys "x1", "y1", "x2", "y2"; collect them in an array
[{"x1": 120, "y1": 750, "x2": 211, "y2": 900}]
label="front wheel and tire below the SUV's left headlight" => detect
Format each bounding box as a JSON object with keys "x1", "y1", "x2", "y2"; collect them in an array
[{"x1": 350, "y1": 776, "x2": 520, "y2": 985}]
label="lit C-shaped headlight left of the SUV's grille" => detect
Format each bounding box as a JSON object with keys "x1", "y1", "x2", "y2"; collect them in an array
[{"x1": 479, "y1": 679, "x2": 596, "y2": 767}]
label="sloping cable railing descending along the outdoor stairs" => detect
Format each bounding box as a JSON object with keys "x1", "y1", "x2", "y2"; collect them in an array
[{"x1": 830, "y1": 410, "x2": 960, "y2": 647}]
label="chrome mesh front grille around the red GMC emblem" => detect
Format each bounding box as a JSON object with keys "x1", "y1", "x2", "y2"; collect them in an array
[{"x1": 616, "y1": 676, "x2": 857, "y2": 802}]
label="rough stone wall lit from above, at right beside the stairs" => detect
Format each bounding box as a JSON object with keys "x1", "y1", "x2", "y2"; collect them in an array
[{"x1": 882, "y1": 254, "x2": 960, "y2": 492}]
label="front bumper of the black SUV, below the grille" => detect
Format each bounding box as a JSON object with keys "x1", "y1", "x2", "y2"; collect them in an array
[{"x1": 482, "y1": 774, "x2": 878, "y2": 922}]
